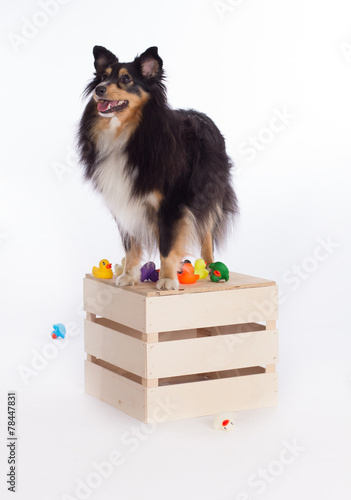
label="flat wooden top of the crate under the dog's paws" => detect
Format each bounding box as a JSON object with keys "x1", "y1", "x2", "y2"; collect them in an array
[{"x1": 85, "y1": 271, "x2": 276, "y2": 297}]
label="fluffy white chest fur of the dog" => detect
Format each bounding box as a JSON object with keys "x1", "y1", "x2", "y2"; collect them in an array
[{"x1": 94, "y1": 117, "x2": 153, "y2": 248}]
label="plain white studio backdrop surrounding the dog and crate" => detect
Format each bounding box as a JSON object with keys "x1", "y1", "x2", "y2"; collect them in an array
[{"x1": 0, "y1": 0, "x2": 351, "y2": 500}]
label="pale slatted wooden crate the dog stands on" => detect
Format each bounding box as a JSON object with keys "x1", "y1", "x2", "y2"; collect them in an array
[{"x1": 84, "y1": 272, "x2": 278, "y2": 423}]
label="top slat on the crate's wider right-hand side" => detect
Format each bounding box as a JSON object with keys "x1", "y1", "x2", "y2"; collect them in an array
[{"x1": 146, "y1": 286, "x2": 278, "y2": 332}]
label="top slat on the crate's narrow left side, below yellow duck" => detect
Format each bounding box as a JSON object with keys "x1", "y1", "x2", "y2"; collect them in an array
[{"x1": 84, "y1": 278, "x2": 147, "y2": 332}]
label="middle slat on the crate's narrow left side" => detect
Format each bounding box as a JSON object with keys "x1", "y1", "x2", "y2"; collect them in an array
[{"x1": 84, "y1": 320, "x2": 146, "y2": 377}]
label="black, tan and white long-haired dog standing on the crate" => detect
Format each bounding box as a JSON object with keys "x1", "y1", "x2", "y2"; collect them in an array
[{"x1": 78, "y1": 46, "x2": 238, "y2": 290}]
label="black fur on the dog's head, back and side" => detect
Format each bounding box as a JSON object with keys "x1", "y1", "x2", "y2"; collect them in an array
[{"x1": 79, "y1": 47, "x2": 238, "y2": 262}]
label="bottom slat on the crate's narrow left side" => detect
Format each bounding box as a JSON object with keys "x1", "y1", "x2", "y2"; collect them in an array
[{"x1": 85, "y1": 361, "x2": 146, "y2": 422}]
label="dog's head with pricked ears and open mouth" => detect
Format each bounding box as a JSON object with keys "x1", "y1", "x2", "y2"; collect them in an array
[{"x1": 85, "y1": 45, "x2": 164, "y2": 122}]
